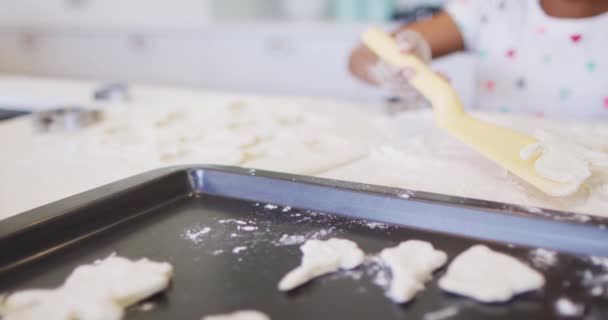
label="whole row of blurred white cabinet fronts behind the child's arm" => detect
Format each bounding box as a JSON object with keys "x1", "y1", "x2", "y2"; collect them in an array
[{"x1": 0, "y1": 22, "x2": 472, "y2": 102}]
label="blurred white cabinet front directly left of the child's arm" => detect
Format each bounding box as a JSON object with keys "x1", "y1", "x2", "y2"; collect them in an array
[{"x1": 192, "y1": 24, "x2": 382, "y2": 99}]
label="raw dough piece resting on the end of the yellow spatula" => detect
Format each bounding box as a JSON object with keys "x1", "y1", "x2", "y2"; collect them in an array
[{"x1": 520, "y1": 130, "x2": 608, "y2": 196}]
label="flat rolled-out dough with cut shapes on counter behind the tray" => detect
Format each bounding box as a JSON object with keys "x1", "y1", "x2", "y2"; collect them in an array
[{"x1": 67, "y1": 97, "x2": 378, "y2": 175}]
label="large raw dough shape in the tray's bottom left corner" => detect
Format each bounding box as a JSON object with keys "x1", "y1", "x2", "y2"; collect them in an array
[{"x1": 0, "y1": 256, "x2": 173, "y2": 320}]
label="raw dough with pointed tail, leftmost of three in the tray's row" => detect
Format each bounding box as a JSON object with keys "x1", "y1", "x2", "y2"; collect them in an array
[{"x1": 279, "y1": 238, "x2": 365, "y2": 291}]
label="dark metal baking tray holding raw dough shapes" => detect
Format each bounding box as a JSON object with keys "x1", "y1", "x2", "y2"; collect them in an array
[{"x1": 0, "y1": 166, "x2": 608, "y2": 320}]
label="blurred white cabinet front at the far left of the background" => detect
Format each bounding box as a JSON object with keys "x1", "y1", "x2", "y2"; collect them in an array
[{"x1": 0, "y1": 32, "x2": 204, "y2": 85}]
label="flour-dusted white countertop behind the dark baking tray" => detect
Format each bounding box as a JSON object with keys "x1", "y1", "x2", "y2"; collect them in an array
[{"x1": 0, "y1": 77, "x2": 608, "y2": 219}]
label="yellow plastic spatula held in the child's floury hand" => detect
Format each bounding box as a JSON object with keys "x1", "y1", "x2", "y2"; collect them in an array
[{"x1": 363, "y1": 28, "x2": 577, "y2": 196}]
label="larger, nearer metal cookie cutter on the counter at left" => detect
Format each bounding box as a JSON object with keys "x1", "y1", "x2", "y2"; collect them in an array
[{"x1": 32, "y1": 107, "x2": 103, "y2": 132}]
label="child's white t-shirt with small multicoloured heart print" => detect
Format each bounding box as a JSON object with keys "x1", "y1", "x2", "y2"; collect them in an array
[{"x1": 446, "y1": 0, "x2": 608, "y2": 120}]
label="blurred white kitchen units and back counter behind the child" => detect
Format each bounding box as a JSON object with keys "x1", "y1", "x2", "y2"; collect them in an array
[{"x1": 0, "y1": 0, "x2": 473, "y2": 103}]
